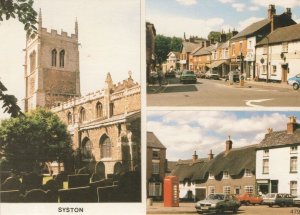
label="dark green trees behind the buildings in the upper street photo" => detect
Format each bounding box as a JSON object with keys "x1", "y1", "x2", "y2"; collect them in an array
[{"x1": 155, "y1": 34, "x2": 182, "y2": 64}]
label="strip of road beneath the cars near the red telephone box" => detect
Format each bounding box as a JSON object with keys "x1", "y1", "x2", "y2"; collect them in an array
[{"x1": 147, "y1": 203, "x2": 300, "y2": 215}]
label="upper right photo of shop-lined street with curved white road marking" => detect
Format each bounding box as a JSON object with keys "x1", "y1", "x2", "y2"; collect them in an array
[{"x1": 146, "y1": 0, "x2": 300, "y2": 107}]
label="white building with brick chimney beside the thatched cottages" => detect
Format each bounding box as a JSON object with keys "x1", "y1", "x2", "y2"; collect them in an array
[{"x1": 256, "y1": 117, "x2": 300, "y2": 195}]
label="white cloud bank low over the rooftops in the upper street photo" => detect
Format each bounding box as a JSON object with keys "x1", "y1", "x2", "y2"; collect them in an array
[{"x1": 148, "y1": 13, "x2": 224, "y2": 38}]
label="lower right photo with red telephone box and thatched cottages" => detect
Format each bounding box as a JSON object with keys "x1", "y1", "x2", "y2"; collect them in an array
[{"x1": 147, "y1": 110, "x2": 300, "y2": 215}]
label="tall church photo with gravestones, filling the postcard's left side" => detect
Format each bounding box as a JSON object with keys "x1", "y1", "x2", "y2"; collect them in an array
[{"x1": 0, "y1": 0, "x2": 142, "y2": 212}]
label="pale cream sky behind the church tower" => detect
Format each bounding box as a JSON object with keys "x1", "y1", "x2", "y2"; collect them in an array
[{"x1": 0, "y1": 0, "x2": 141, "y2": 119}]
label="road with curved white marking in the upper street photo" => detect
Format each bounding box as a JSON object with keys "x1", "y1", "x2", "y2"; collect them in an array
[{"x1": 147, "y1": 78, "x2": 300, "y2": 107}]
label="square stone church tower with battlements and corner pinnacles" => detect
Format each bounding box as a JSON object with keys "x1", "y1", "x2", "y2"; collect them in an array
[{"x1": 24, "y1": 10, "x2": 80, "y2": 112}]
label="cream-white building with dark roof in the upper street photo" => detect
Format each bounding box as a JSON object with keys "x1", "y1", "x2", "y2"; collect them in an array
[{"x1": 256, "y1": 24, "x2": 300, "y2": 83}]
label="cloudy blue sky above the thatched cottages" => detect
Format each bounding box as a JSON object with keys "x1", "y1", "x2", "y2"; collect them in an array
[{"x1": 147, "y1": 110, "x2": 300, "y2": 161}]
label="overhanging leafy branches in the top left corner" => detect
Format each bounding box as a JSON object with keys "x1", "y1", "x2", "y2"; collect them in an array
[{"x1": 0, "y1": 0, "x2": 37, "y2": 37}]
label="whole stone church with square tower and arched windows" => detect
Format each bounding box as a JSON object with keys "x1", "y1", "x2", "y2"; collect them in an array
[{"x1": 24, "y1": 11, "x2": 141, "y2": 177}]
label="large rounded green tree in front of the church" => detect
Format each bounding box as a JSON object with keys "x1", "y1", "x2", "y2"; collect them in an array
[{"x1": 0, "y1": 109, "x2": 72, "y2": 171}]
